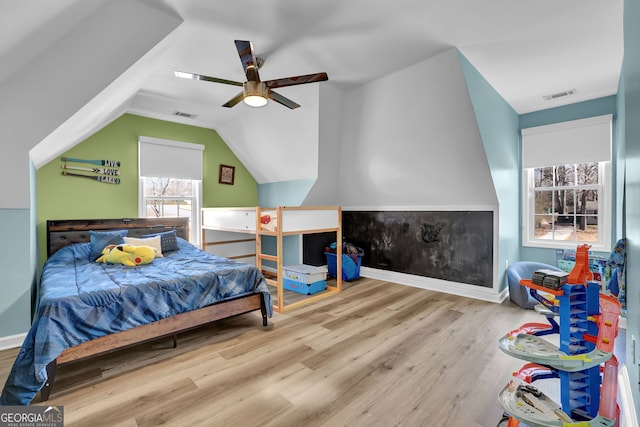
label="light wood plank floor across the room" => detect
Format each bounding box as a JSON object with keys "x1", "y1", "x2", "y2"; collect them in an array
[{"x1": 0, "y1": 278, "x2": 541, "y2": 427}]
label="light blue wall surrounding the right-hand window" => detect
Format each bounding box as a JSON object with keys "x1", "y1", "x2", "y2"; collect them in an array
[{"x1": 518, "y1": 95, "x2": 619, "y2": 265}]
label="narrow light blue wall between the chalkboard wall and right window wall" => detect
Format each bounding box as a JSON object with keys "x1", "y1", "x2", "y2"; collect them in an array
[{"x1": 460, "y1": 49, "x2": 520, "y2": 290}]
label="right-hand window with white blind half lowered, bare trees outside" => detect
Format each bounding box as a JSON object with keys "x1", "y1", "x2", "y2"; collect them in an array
[{"x1": 522, "y1": 116, "x2": 612, "y2": 252}]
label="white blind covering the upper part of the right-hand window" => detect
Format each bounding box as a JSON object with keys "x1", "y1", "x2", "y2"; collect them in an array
[{"x1": 522, "y1": 114, "x2": 612, "y2": 168}]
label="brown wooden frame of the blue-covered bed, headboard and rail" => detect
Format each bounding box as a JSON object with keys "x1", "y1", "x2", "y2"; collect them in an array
[{"x1": 40, "y1": 218, "x2": 268, "y2": 401}]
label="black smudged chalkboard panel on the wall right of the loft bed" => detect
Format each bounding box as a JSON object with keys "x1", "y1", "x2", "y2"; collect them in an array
[{"x1": 342, "y1": 211, "x2": 493, "y2": 288}]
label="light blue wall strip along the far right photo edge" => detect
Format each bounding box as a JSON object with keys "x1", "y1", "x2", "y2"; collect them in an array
[{"x1": 618, "y1": 0, "x2": 640, "y2": 414}]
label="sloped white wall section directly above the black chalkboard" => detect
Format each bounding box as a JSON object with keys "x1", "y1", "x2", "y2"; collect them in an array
[{"x1": 340, "y1": 49, "x2": 497, "y2": 207}]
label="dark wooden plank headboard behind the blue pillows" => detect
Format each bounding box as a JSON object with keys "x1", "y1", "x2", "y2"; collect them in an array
[{"x1": 47, "y1": 218, "x2": 189, "y2": 257}]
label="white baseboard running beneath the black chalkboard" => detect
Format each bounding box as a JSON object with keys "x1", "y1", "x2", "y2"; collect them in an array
[{"x1": 360, "y1": 267, "x2": 509, "y2": 304}]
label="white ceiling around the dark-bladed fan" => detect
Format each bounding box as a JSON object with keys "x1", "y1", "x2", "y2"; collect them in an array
[{"x1": 0, "y1": 0, "x2": 623, "y2": 132}]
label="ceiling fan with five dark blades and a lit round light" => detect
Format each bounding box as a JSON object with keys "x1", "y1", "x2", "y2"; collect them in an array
[{"x1": 174, "y1": 40, "x2": 329, "y2": 110}]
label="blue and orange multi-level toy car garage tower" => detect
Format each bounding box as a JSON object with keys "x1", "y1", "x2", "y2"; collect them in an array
[{"x1": 498, "y1": 245, "x2": 620, "y2": 427}]
